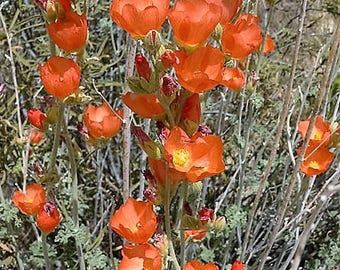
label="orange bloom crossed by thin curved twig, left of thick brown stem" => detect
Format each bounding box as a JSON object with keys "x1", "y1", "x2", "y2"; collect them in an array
[{"x1": 84, "y1": 102, "x2": 123, "y2": 139}]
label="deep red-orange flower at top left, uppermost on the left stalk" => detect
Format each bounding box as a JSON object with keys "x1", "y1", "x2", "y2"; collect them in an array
[{"x1": 46, "y1": 10, "x2": 87, "y2": 52}]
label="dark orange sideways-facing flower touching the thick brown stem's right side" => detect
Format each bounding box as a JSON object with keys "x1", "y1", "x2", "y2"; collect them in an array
[{"x1": 122, "y1": 92, "x2": 164, "y2": 118}]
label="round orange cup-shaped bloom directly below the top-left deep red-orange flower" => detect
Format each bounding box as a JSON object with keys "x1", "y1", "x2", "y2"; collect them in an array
[{"x1": 39, "y1": 56, "x2": 80, "y2": 98}]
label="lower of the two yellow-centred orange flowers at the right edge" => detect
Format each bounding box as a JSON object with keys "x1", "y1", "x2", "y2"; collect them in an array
[{"x1": 297, "y1": 145, "x2": 334, "y2": 176}]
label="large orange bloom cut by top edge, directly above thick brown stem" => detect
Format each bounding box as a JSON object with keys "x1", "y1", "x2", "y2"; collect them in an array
[{"x1": 110, "y1": 0, "x2": 170, "y2": 38}]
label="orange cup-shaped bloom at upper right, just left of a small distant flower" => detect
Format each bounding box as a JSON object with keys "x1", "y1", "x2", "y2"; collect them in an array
[{"x1": 221, "y1": 14, "x2": 262, "y2": 59}]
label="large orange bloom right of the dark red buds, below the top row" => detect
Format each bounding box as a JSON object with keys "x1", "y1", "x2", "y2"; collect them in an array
[{"x1": 174, "y1": 46, "x2": 224, "y2": 93}]
